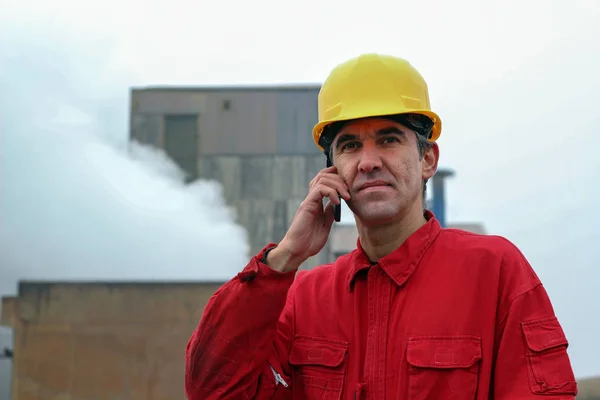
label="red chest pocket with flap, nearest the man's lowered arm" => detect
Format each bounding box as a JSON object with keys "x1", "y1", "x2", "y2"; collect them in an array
[{"x1": 406, "y1": 336, "x2": 481, "y2": 400}]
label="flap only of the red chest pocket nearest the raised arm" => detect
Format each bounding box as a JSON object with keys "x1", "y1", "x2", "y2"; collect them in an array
[{"x1": 289, "y1": 337, "x2": 348, "y2": 367}]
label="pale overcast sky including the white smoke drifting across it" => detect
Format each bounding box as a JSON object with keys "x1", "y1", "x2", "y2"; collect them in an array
[{"x1": 0, "y1": 0, "x2": 600, "y2": 376}]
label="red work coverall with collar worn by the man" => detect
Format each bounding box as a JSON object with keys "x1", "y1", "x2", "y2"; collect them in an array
[{"x1": 185, "y1": 213, "x2": 577, "y2": 400}]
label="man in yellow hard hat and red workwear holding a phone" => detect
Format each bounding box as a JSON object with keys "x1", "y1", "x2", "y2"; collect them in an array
[{"x1": 185, "y1": 54, "x2": 577, "y2": 400}]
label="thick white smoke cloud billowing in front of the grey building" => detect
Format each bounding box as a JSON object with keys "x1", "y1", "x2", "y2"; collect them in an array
[{"x1": 0, "y1": 21, "x2": 248, "y2": 296}]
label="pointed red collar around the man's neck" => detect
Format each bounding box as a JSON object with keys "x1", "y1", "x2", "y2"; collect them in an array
[{"x1": 346, "y1": 210, "x2": 441, "y2": 291}]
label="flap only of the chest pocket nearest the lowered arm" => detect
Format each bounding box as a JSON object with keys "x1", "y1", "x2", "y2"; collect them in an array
[{"x1": 406, "y1": 336, "x2": 481, "y2": 368}]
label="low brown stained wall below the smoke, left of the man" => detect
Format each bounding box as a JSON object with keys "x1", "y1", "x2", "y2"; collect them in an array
[{"x1": 2, "y1": 283, "x2": 219, "y2": 400}]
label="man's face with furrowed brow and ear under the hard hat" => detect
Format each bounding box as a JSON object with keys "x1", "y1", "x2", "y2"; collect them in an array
[{"x1": 331, "y1": 118, "x2": 439, "y2": 226}]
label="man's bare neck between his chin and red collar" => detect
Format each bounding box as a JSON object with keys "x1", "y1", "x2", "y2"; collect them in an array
[{"x1": 356, "y1": 205, "x2": 427, "y2": 262}]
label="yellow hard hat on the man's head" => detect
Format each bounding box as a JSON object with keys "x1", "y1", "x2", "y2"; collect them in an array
[{"x1": 313, "y1": 54, "x2": 442, "y2": 150}]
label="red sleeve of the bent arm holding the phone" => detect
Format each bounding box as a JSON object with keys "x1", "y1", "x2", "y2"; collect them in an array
[{"x1": 185, "y1": 246, "x2": 295, "y2": 400}]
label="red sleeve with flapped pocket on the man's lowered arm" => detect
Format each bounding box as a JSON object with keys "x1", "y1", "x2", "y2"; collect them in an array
[{"x1": 490, "y1": 250, "x2": 577, "y2": 400}]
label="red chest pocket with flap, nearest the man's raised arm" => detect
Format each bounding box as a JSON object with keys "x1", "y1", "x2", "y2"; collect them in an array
[{"x1": 289, "y1": 335, "x2": 349, "y2": 400}]
